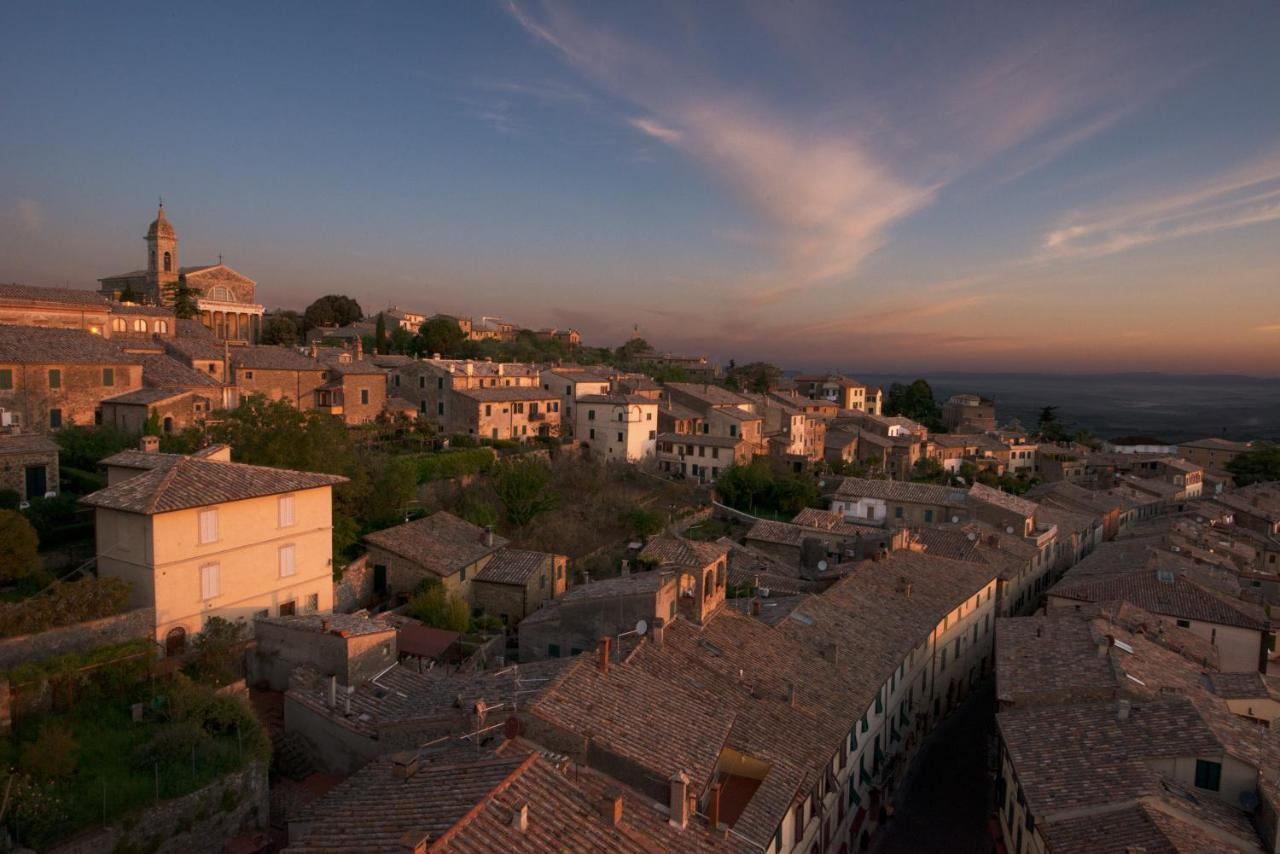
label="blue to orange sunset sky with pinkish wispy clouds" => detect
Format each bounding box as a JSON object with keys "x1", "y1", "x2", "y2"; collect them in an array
[{"x1": 0, "y1": 0, "x2": 1280, "y2": 375}]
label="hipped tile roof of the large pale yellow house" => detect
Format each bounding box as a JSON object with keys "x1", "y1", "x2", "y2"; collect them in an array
[{"x1": 81, "y1": 457, "x2": 347, "y2": 515}]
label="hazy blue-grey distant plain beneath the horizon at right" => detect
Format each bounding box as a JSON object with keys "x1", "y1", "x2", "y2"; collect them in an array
[{"x1": 851, "y1": 371, "x2": 1280, "y2": 442}]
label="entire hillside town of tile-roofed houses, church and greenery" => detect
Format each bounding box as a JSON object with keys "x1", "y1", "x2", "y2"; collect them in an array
[{"x1": 0, "y1": 206, "x2": 1280, "y2": 854}]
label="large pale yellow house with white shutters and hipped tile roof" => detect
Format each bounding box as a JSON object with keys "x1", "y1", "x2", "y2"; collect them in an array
[{"x1": 84, "y1": 455, "x2": 346, "y2": 654}]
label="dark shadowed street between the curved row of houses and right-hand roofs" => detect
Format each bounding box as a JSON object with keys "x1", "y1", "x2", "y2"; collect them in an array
[{"x1": 872, "y1": 680, "x2": 996, "y2": 854}]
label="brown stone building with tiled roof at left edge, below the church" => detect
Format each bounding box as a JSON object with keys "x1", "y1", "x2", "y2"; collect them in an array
[{"x1": 0, "y1": 326, "x2": 142, "y2": 433}]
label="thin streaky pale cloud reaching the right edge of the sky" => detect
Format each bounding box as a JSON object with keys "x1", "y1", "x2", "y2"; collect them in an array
[{"x1": 1041, "y1": 151, "x2": 1280, "y2": 259}]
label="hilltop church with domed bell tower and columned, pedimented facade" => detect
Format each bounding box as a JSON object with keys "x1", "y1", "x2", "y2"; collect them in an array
[{"x1": 99, "y1": 204, "x2": 262, "y2": 343}]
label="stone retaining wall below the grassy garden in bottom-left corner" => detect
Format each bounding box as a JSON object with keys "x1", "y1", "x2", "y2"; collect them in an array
[{"x1": 49, "y1": 763, "x2": 270, "y2": 854}]
